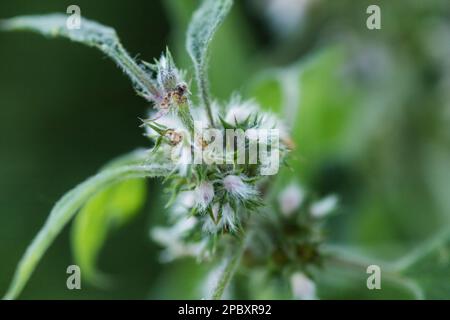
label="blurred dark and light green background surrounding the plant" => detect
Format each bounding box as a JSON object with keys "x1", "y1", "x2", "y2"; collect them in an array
[{"x1": 0, "y1": 0, "x2": 450, "y2": 299}]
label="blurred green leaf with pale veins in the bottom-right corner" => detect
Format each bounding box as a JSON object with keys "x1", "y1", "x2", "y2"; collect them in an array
[{"x1": 315, "y1": 228, "x2": 450, "y2": 299}]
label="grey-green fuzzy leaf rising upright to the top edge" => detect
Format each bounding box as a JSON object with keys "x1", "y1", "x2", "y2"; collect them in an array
[{"x1": 186, "y1": 0, "x2": 233, "y2": 122}]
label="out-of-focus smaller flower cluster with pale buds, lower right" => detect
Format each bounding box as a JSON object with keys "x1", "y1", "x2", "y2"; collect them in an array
[{"x1": 243, "y1": 182, "x2": 338, "y2": 299}]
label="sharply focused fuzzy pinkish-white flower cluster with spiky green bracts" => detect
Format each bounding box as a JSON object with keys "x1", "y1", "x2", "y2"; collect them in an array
[{"x1": 143, "y1": 53, "x2": 288, "y2": 260}]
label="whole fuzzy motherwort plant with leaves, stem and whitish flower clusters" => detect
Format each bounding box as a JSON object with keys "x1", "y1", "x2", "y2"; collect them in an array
[{"x1": 1, "y1": 0, "x2": 336, "y2": 299}]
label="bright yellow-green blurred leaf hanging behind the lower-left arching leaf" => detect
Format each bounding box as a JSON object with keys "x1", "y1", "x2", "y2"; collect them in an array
[{"x1": 72, "y1": 179, "x2": 146, "y2": 285}]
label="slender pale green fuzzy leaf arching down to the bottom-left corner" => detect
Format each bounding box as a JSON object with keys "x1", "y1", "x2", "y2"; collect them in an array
[{"x1": 4, "y1": 153, "x2": 172, "y2": 299}]
